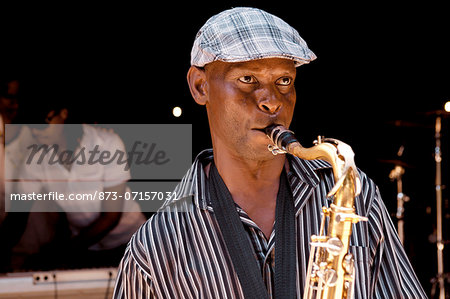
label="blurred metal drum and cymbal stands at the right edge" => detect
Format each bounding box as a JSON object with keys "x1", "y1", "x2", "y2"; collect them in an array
[{"x1": 379, "y1": 106, "x2": 450, "y2": 299}]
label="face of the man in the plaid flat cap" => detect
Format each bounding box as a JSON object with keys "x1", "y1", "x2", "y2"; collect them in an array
[{"x1": 205, "y1": 58, "x2": 296, "y2": 160}]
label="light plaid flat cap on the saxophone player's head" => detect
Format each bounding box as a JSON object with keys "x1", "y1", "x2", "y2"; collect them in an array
[{"x1": 191, "y1": 7, "x2": 316, "y2": 67}]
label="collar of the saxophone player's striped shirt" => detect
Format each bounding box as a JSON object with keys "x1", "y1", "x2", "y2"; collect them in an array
[{"x1": 167, "y1": 149, "x2": 331, "y2": 209}]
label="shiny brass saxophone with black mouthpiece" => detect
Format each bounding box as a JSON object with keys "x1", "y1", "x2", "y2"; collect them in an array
[{"x1": 266, "y1": 125, "x2": 367, "y2": 299}]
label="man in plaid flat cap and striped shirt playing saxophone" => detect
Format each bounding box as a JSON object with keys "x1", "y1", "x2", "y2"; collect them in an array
[{"x1": 114, "y1": 8, "x2": 426, "y2": 298}]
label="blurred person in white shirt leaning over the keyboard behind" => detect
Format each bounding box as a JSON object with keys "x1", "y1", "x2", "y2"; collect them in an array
[{"x1": 12, "y1": 101, "x2": 146, "y2": 268}]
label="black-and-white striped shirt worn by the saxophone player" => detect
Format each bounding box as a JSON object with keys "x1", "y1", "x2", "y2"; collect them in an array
[{"x1": 114, "y1": 150, "x2": 427, "y2": 299}]
